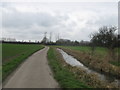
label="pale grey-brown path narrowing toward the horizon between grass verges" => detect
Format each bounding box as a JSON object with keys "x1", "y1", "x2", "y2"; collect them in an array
[{"x1": 3, "y1": 47, "x2": 58, "y2": 88}]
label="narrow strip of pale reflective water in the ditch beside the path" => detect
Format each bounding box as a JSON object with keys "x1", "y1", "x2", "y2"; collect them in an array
[{"x1": 57, "y1": 48, "x2": 120, "y2": 84}]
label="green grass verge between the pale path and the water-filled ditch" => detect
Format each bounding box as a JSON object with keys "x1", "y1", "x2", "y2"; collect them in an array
[{"x1": 47, "y1": 48, "x2": 89, "y2": 88}]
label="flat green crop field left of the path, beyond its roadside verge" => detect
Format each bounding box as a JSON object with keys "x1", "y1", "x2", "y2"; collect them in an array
[{"x1": 2, "y1": 44, "x2": 43, "y2": 62}]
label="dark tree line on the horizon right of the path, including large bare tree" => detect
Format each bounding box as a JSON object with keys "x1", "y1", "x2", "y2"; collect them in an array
[{"x1": 41, "y1": 26, "x2": 120, "y2": 50}]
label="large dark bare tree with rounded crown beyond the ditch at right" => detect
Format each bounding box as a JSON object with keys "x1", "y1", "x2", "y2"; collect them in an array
[{"x1": 91, "y1": 26, "x2": 118, "y2": 59}]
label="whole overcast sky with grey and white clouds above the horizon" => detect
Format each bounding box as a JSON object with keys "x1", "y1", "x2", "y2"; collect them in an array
[{"x1": 0, "y1": 0, "x2": 118, "y2": 41}]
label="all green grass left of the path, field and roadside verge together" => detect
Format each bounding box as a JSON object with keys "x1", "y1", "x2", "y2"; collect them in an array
[{"x1": 2, "y1": 44, "x2": 44, "y2": 80}]
